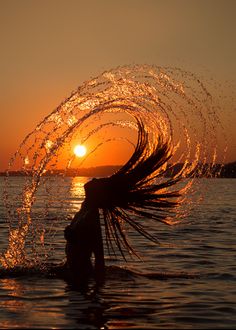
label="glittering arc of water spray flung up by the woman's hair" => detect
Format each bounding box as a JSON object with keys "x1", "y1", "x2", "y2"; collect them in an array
[{"x1": 0, "y1": 66, "x2": 225, "y2": 267}]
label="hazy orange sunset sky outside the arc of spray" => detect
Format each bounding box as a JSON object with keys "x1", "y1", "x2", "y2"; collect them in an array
[{"x1": 0, "y1": 0, "x2": 236, "y2": 171}]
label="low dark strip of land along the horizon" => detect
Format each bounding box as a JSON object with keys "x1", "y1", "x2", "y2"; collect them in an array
[{"x1": 0, "y1": 161, "x2": 236, "y2": 178}]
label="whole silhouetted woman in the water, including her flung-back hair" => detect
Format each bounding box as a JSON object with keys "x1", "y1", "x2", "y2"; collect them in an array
[{"x1": 62, "y1": 118, "x2": 180, "y2": 282}]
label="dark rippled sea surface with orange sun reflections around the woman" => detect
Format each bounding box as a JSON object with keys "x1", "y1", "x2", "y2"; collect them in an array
[{"x1": 0, "y1": 177, "x2": 236, "y2": 329}]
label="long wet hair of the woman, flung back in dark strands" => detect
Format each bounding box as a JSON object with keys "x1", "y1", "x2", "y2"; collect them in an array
[{"x1": 85, "y1": 120, "x2": 180, "y2": 259}]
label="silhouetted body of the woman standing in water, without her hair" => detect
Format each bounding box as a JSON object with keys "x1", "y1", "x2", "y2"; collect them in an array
[{"x1": 64, "y1": 180, "x2": 105, "y2": 282}]
